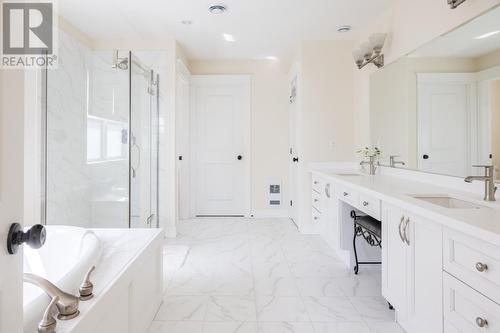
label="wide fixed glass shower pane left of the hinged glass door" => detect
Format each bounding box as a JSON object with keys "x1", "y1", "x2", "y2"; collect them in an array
[{"x1": 45, "y1": 47, "x2": 129, "y2": 228}]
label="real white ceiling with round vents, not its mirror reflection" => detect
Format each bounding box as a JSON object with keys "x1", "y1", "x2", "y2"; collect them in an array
[{"x1": 58, "y1": 0, "x2": 393, "y2": 59}]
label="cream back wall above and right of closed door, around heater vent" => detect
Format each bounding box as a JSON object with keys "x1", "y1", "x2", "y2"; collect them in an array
[{"x1": 189, "y1": 60, "x2": 289, "y2": 217}]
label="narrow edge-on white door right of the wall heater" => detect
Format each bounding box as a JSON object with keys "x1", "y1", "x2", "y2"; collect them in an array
[{"x1": 289, "y1": 76, "x2": 299, "y2": 223}]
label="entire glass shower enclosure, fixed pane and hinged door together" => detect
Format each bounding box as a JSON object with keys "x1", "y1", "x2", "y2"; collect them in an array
[{"x1": 42, "y1": 48, "x2": 159, "y2": 228}]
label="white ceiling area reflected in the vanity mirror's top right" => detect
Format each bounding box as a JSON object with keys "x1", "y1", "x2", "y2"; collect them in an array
[{"x1": 410, "y1": 7, "x2": 500, "y2": 58}]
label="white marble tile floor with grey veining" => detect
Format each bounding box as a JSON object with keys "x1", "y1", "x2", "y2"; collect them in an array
[{"x1": 149, "y1": 218, "x2": 403, "y2": 333}]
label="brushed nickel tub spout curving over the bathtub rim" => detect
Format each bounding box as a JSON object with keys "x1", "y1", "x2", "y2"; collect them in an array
[{"x1": 23, "y1": 273, "x2": 80, "y2": 320}]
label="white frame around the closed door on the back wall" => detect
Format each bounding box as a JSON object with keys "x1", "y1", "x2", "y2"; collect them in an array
[{"x1": 189, "y1": 74, "x2": 252, "y2": 218}]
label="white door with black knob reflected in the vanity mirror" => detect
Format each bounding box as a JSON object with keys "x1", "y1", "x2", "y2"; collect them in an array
[{"x1": 417, "y1": 74, "x2": 475, "y2": 177}]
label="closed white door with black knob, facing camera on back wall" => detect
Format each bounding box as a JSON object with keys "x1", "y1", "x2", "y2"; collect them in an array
[{"x1": 191, "y1": 75, "x2": 250, "y2": 216}]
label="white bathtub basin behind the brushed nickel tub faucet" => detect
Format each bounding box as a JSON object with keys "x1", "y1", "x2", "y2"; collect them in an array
[{"x1": 23, "y1": 226, "x2": 102, "y2": 332}]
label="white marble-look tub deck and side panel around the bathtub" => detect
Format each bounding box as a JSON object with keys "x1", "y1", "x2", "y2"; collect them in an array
[{"x1": 57, "y1": 229, "x2": 164, "y2": 333}]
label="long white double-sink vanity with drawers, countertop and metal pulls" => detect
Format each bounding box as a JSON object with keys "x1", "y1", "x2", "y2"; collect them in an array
[{"x1": 312, "y1": 167, "x2": 500, "y2": 333}]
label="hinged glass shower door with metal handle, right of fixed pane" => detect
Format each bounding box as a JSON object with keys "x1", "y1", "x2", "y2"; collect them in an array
[{"x1": 130, "y1": 53, "x2": 158, "y2": 228}]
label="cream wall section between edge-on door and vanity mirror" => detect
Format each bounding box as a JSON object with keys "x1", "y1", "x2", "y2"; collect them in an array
[{"x1": 296, "y1": 41, "x2": 355, "y2": 233}]
